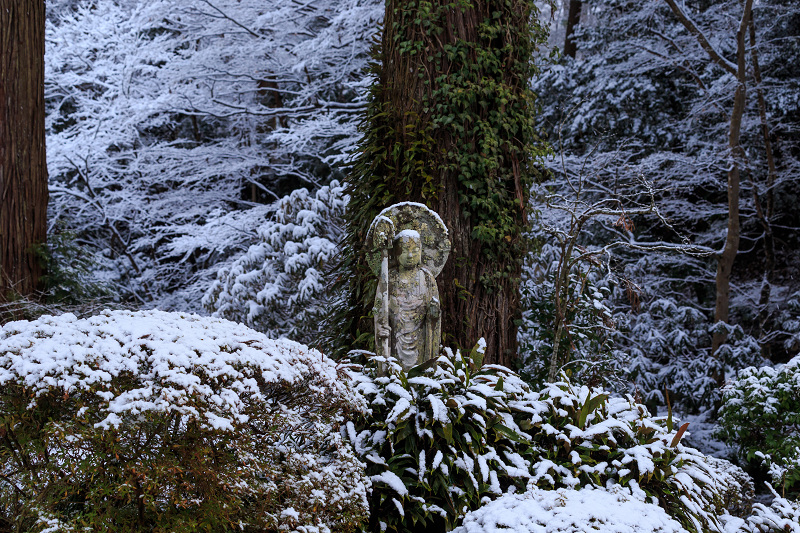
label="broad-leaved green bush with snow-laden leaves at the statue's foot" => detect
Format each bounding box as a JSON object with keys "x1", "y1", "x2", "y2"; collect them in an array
[{"x1": 349, "y1": 348, "x2": 741, "y2": 533}]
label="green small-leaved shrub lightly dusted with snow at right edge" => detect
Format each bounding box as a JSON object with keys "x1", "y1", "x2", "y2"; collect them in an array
[{"x1": 720, "y1": 356, "x2": 800, "y2": 489}]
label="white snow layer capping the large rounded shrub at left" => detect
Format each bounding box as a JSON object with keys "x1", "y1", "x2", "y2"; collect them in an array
[{"x1": 0, "y1": 311, "x2": 357, "y2": 430}]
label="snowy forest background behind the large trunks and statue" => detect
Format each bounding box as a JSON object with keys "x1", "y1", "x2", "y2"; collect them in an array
[{"x1": 3, "y1": 0, "x2": 800, "y2": 528}]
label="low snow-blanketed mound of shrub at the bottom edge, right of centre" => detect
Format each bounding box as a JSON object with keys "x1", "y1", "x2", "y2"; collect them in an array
[{"x1": 453, "y1": 487, "x2": 686, "y2": 533}]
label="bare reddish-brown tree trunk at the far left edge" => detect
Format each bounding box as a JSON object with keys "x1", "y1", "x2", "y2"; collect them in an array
[{"x1": 0, "y1": 0, "x2": 48, "y2": 302}]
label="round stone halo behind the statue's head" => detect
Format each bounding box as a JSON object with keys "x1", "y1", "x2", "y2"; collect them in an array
[{"x1": 365, "y1": 202, "x2": 450, "y2": 277}]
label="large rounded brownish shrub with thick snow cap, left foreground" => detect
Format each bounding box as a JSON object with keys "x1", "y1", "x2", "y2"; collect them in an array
[{"x1": 0, "y1": 311, "x2": 369, "y2": 532}]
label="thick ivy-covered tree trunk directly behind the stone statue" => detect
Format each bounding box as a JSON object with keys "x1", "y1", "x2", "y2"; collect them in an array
[{"x1": 344, "y1": 0, "x2": 544, "y2": 365}]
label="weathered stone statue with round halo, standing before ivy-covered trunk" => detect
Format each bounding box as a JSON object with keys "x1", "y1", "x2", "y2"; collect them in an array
[{"x1": 367, "y1": 202, "x2": 450, "y2": 371}]
